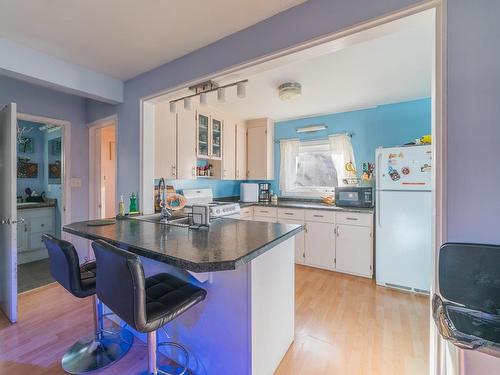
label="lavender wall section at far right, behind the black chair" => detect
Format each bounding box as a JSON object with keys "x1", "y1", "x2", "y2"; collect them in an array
[{"x1": 448, "y1": 0, "x2": 500, "y2": 375}]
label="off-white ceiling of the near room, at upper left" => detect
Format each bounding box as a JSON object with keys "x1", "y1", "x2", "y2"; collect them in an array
[{"x1": 0, "y1": 0, "x2": 305, "y2": 80}]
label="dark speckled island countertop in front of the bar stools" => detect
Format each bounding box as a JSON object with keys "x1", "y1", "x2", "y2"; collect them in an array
[{"x1": 63, "y1": 218, "x2": 303, "y2": 272}]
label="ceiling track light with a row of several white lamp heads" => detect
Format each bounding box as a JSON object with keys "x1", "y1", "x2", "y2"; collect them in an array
[{"x1": 169, "y1": 79, "x2": 248, "y2": 113}]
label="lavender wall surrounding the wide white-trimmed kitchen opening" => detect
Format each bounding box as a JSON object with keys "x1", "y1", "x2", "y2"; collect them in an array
[{"x1": 87, "y1": 0, "x2": 500, "y2": 374}]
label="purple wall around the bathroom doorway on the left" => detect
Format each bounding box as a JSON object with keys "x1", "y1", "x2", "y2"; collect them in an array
[{"x1": 0, "y1": 77, "x2": 89, "y2": 225}]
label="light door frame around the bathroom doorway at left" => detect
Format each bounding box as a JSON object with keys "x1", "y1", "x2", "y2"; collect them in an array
[{"x1": 17, "y1": 112, "x2": 71, "y2": 235}]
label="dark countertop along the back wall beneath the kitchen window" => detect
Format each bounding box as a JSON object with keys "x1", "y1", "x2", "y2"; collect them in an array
[{"x1": 214, "y1": 197, "x2": 374, "y2": 213}]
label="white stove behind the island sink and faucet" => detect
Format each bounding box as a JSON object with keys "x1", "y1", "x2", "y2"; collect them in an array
[{"x1": 182, "y1": 189, "x2": 240, "y2": 219}]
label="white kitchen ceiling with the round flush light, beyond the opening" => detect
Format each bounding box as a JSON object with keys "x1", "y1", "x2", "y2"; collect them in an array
[{"x1": 162, "y1": 12, "x2": 433, "y2": 120}]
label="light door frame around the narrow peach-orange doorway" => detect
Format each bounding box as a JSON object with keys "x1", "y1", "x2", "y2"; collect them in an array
[{"x1": 87, "y1": 114, "x2": 118, "y2": 220}]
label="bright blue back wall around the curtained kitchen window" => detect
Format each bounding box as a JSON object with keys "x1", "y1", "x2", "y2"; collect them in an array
[{"x1": 272, "y1": 98, "x2": 431, "y2": 193}]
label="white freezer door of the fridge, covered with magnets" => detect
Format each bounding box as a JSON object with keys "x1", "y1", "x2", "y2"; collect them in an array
[{"x1": 376, "y1": 145, "x2": 432, "y2": 190}]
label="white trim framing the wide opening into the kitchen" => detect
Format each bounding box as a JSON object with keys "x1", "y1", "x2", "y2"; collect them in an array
[{"x1": 139, "y1": 0, "x2": 452, "y2": 375}]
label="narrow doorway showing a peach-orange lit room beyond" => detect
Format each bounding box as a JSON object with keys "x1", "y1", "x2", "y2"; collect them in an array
[{"x1": 89, "y1": 117, "x2": 117, "y2": 219}]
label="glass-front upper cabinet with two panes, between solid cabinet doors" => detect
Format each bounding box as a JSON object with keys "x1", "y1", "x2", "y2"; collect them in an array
[{"x1": 196, "y1": 112, "x2": 222, "y2": 160}]
